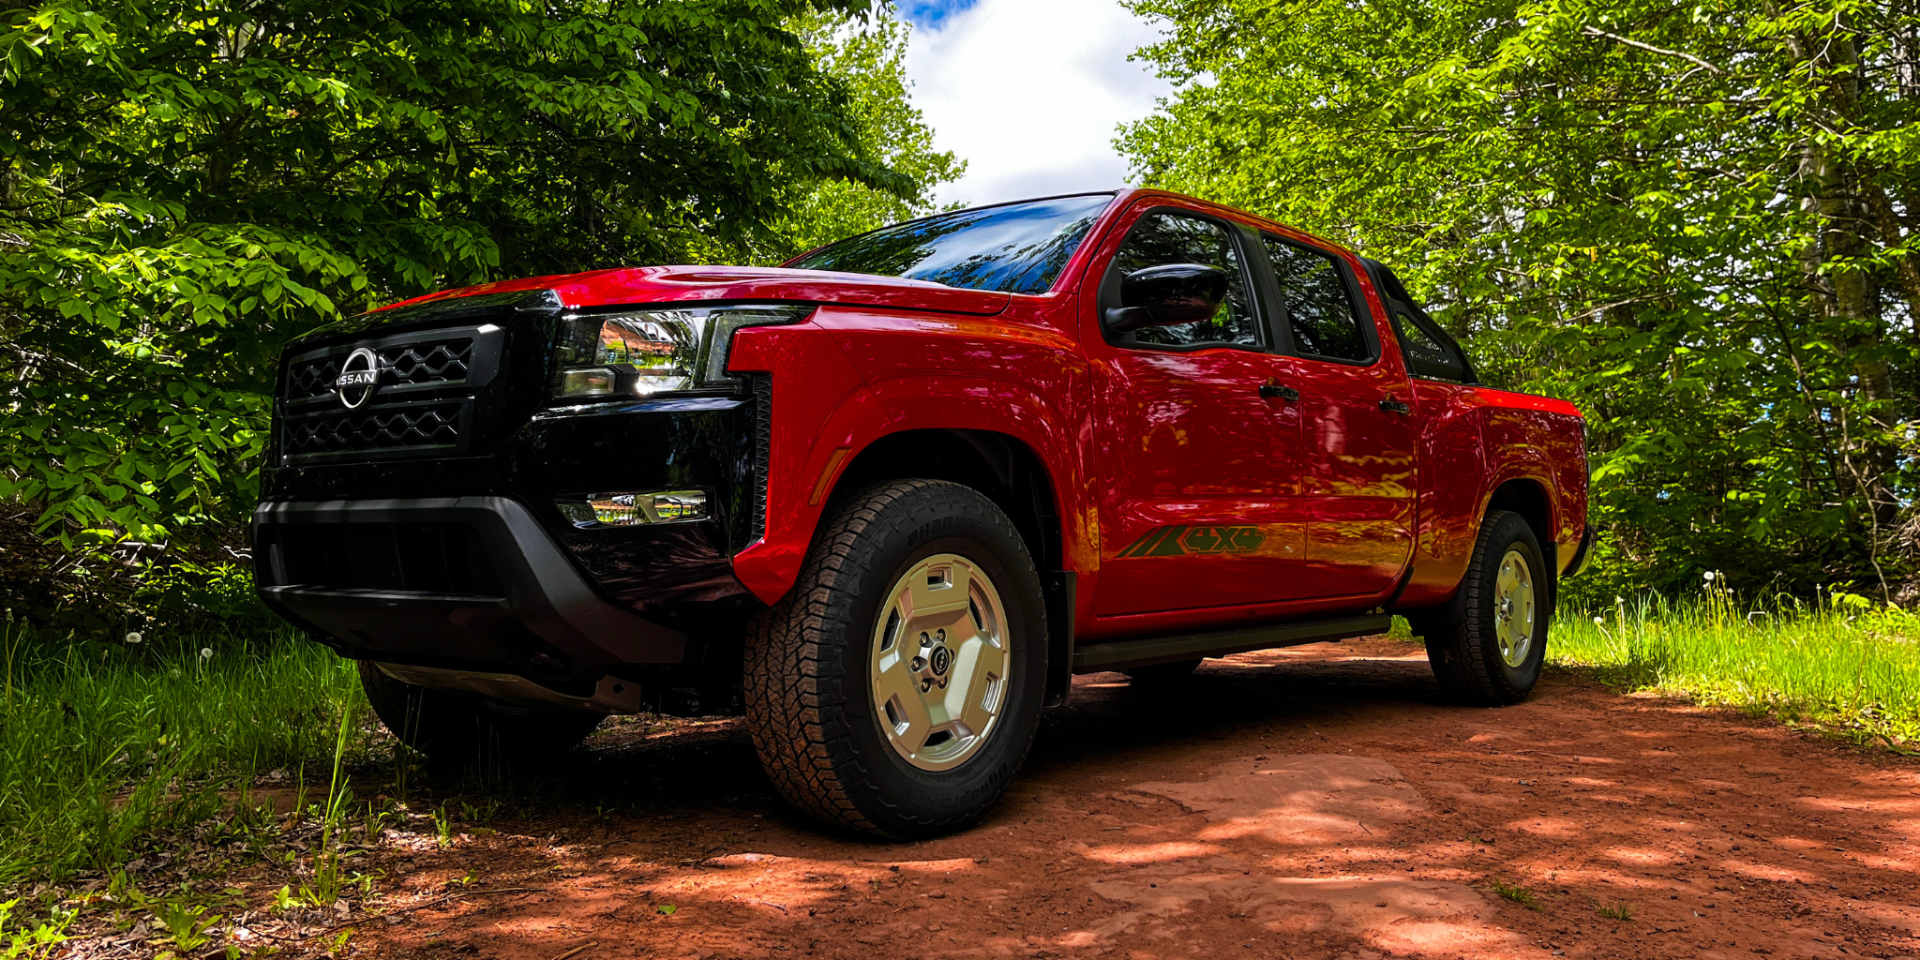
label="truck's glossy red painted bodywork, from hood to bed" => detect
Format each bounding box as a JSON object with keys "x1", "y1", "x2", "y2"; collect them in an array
[{"x1": 382, "y1": 190, "x2": 1586, "y2": 639}]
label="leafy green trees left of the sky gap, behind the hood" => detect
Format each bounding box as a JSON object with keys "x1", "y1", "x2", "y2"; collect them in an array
[{"x1": 0, "y1": 0, "x2": 964, "y2": 636}]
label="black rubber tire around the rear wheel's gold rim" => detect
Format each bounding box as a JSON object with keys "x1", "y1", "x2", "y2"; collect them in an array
[{"x1": 1413, "y1": 511, "x2": 1553, "y2": 707}]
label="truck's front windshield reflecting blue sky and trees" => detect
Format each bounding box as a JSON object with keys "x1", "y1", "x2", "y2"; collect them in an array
[{"x1": 787, "y1": 194, "x2": 1114, "y2": 294}]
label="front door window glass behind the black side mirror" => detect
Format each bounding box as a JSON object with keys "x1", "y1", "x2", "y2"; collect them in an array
[{"x1": 1114, "y1": 213, "x2": 1263, "y2": 349}]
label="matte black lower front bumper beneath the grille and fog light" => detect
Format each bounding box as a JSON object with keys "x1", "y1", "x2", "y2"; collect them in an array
[{"x1": 253, "y1": 495, "x2": 687, "y2": 710}]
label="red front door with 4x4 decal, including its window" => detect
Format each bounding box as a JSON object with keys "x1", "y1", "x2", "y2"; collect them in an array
[{"x1": 1089, "y1": 209, "x2": 1306, "y2": 616}]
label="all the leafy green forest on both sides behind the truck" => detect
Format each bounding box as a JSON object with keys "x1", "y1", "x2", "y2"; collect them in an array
[{"x1": 0, "y1": 0, "x2": 1920, "y2": 634}]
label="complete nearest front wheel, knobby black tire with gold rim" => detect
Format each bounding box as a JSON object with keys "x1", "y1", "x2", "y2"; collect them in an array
[{"x1": 745, "y1": 480, "x2": 1046, "y2": 839}]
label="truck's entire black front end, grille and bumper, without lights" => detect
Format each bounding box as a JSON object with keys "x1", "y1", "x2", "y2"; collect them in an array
[{"x1": 253, "y1": 292, "x2": 772, "y2": 708}]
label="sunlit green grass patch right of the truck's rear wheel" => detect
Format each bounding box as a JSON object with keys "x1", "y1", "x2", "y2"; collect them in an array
[{"x1": 1548, "y1": 584, "x2": 1920, "y2": 751}]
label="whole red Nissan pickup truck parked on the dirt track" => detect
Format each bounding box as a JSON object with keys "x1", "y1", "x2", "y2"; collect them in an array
[{"x1": 253, "y1": 190, "x2": 1592, "y2": 837}]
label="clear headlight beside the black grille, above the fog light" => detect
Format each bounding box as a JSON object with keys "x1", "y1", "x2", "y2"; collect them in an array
[{"x1": 553, "y1": 303, "x2": 814, "y2": 399}]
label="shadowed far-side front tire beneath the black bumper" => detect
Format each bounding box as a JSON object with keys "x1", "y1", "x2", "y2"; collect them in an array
[{"x1": 359, "y1": 660, "x2": 603, "y2": 770}]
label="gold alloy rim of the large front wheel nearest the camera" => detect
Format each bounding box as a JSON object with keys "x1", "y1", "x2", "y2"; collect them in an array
[{"x1": 868, "y1": 553, "x2": 1012, "y2": 770}]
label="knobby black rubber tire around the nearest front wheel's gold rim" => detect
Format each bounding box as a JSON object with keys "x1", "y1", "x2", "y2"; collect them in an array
[{"x1": 743, "y1": 480, "x2": 1046, "y2": 839}]
